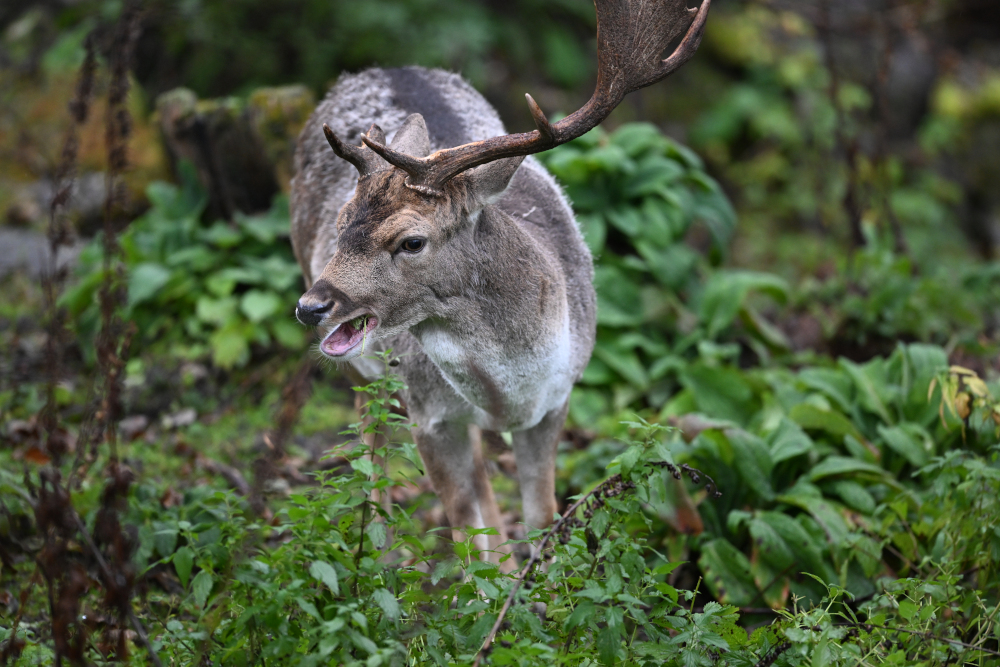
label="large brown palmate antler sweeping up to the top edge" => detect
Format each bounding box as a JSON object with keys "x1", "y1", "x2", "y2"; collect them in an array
[{"x1": 360, "y1": 0, "x2": 711, "y2": 196}]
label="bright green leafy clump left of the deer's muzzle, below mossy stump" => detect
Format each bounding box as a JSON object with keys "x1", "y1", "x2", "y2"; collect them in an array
[{"x1": 63, "y1": 164, "x2": 306, "y2": 368}]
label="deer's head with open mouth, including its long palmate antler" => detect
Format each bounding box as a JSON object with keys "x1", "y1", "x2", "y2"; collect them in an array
[{"x1": 296, "y1": 0, "x2": 711, "y2": 360}]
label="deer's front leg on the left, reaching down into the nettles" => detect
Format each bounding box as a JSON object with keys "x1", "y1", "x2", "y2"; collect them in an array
[{"x1": 413, "y1": 422, "x2": 515, "y2": 570}]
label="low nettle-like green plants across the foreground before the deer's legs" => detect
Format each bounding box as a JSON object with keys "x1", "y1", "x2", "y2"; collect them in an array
[{"x1": 138, "y1": 362, "x2": 1000, "y2": 667}]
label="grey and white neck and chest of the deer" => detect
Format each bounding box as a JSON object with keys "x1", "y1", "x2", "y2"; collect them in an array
[{"x1": 411, "y1": 207, "x2": 575, "y2": 431}]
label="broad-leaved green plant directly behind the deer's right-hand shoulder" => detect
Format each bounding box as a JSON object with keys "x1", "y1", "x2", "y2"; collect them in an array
[{"x1": 541, "y1": 123, "x2": 788, "y2": 424}]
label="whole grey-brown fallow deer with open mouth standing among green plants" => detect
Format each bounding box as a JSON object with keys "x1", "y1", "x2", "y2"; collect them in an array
[{"x1": 290, "y1": 0, "x2": 711, "y2": 571}]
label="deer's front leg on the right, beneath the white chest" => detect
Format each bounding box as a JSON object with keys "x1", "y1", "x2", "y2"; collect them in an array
[{"x1": 511, "y1": 402, "x2": 569, "y2": 528}]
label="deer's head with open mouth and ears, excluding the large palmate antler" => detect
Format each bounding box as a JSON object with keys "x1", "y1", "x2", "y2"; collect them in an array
[{"x1": 296, "y1": 114, "x2": 523, "y2": 361}]
